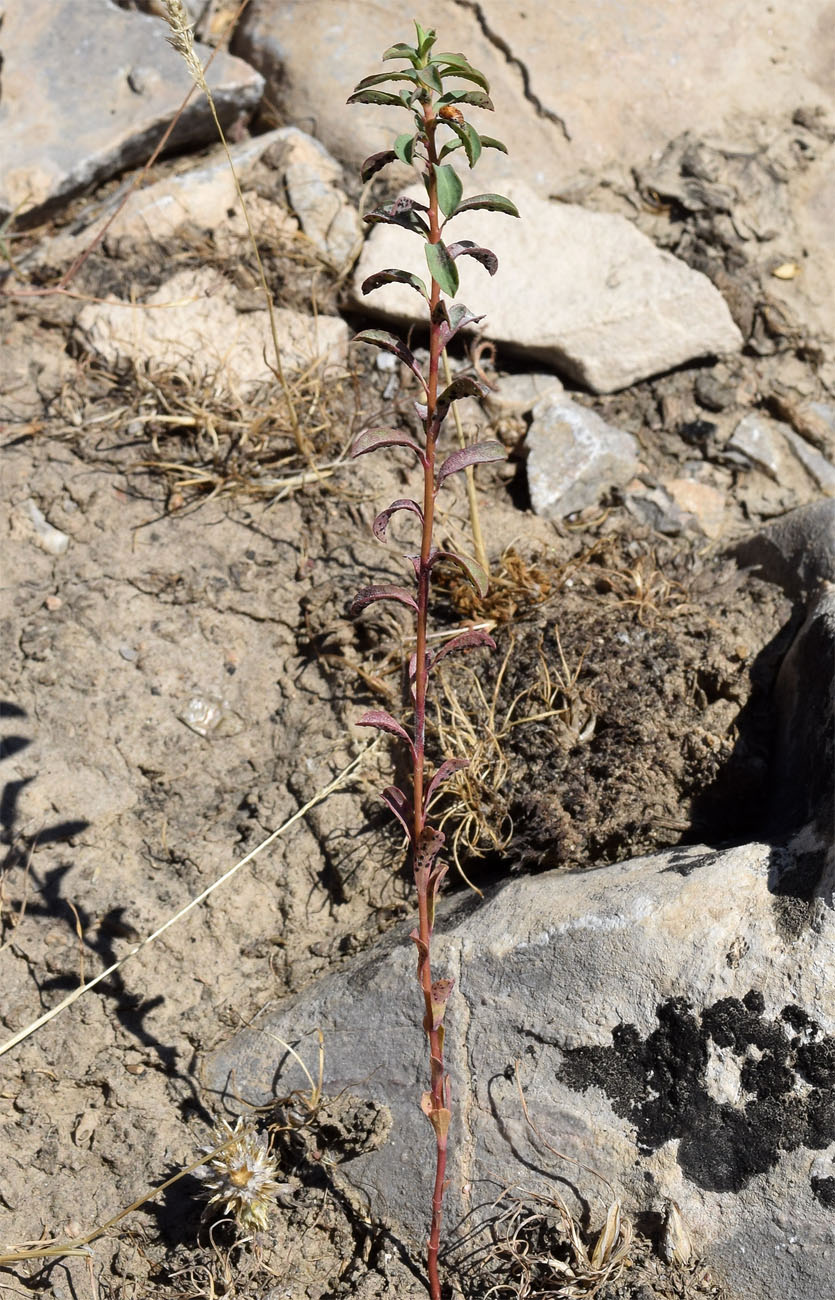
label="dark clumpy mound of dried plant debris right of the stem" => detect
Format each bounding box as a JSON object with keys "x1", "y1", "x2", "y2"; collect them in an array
[{"x1": 434, "y1": 537, "x2": 787, "y2": 883}]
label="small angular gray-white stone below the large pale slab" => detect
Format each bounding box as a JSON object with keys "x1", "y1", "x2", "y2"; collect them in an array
[{"x1": 525, "y1": 394, "x2": 640, "y2": 519}]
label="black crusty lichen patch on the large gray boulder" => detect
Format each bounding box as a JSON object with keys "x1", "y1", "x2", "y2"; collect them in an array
[{"x1": 559, "y1": 989, "x2": 835, "y2": 1199}]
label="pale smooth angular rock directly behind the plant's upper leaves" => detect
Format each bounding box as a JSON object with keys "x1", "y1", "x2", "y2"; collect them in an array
[{"x1": 354, "y1": 178, "x2": 741, "y2": 393}]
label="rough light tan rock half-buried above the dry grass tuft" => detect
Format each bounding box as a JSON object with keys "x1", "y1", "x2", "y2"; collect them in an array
[{"x1": 78, "y1": 268, "x2": 349, "y2": 397}]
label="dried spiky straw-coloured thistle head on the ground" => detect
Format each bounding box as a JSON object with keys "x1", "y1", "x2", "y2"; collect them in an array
[{"x1": 195, "y1": 1115, "x2": 290, "y2": 1231}]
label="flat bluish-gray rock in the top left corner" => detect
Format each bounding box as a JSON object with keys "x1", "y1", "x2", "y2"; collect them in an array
[{"x1": 0, "y1": 0, "x2": 264, "y2": 216}]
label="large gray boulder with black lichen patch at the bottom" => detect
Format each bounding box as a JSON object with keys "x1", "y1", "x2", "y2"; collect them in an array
[{"x1": 205, "y1": 844, "x2": 835, "y2": 1300}]
